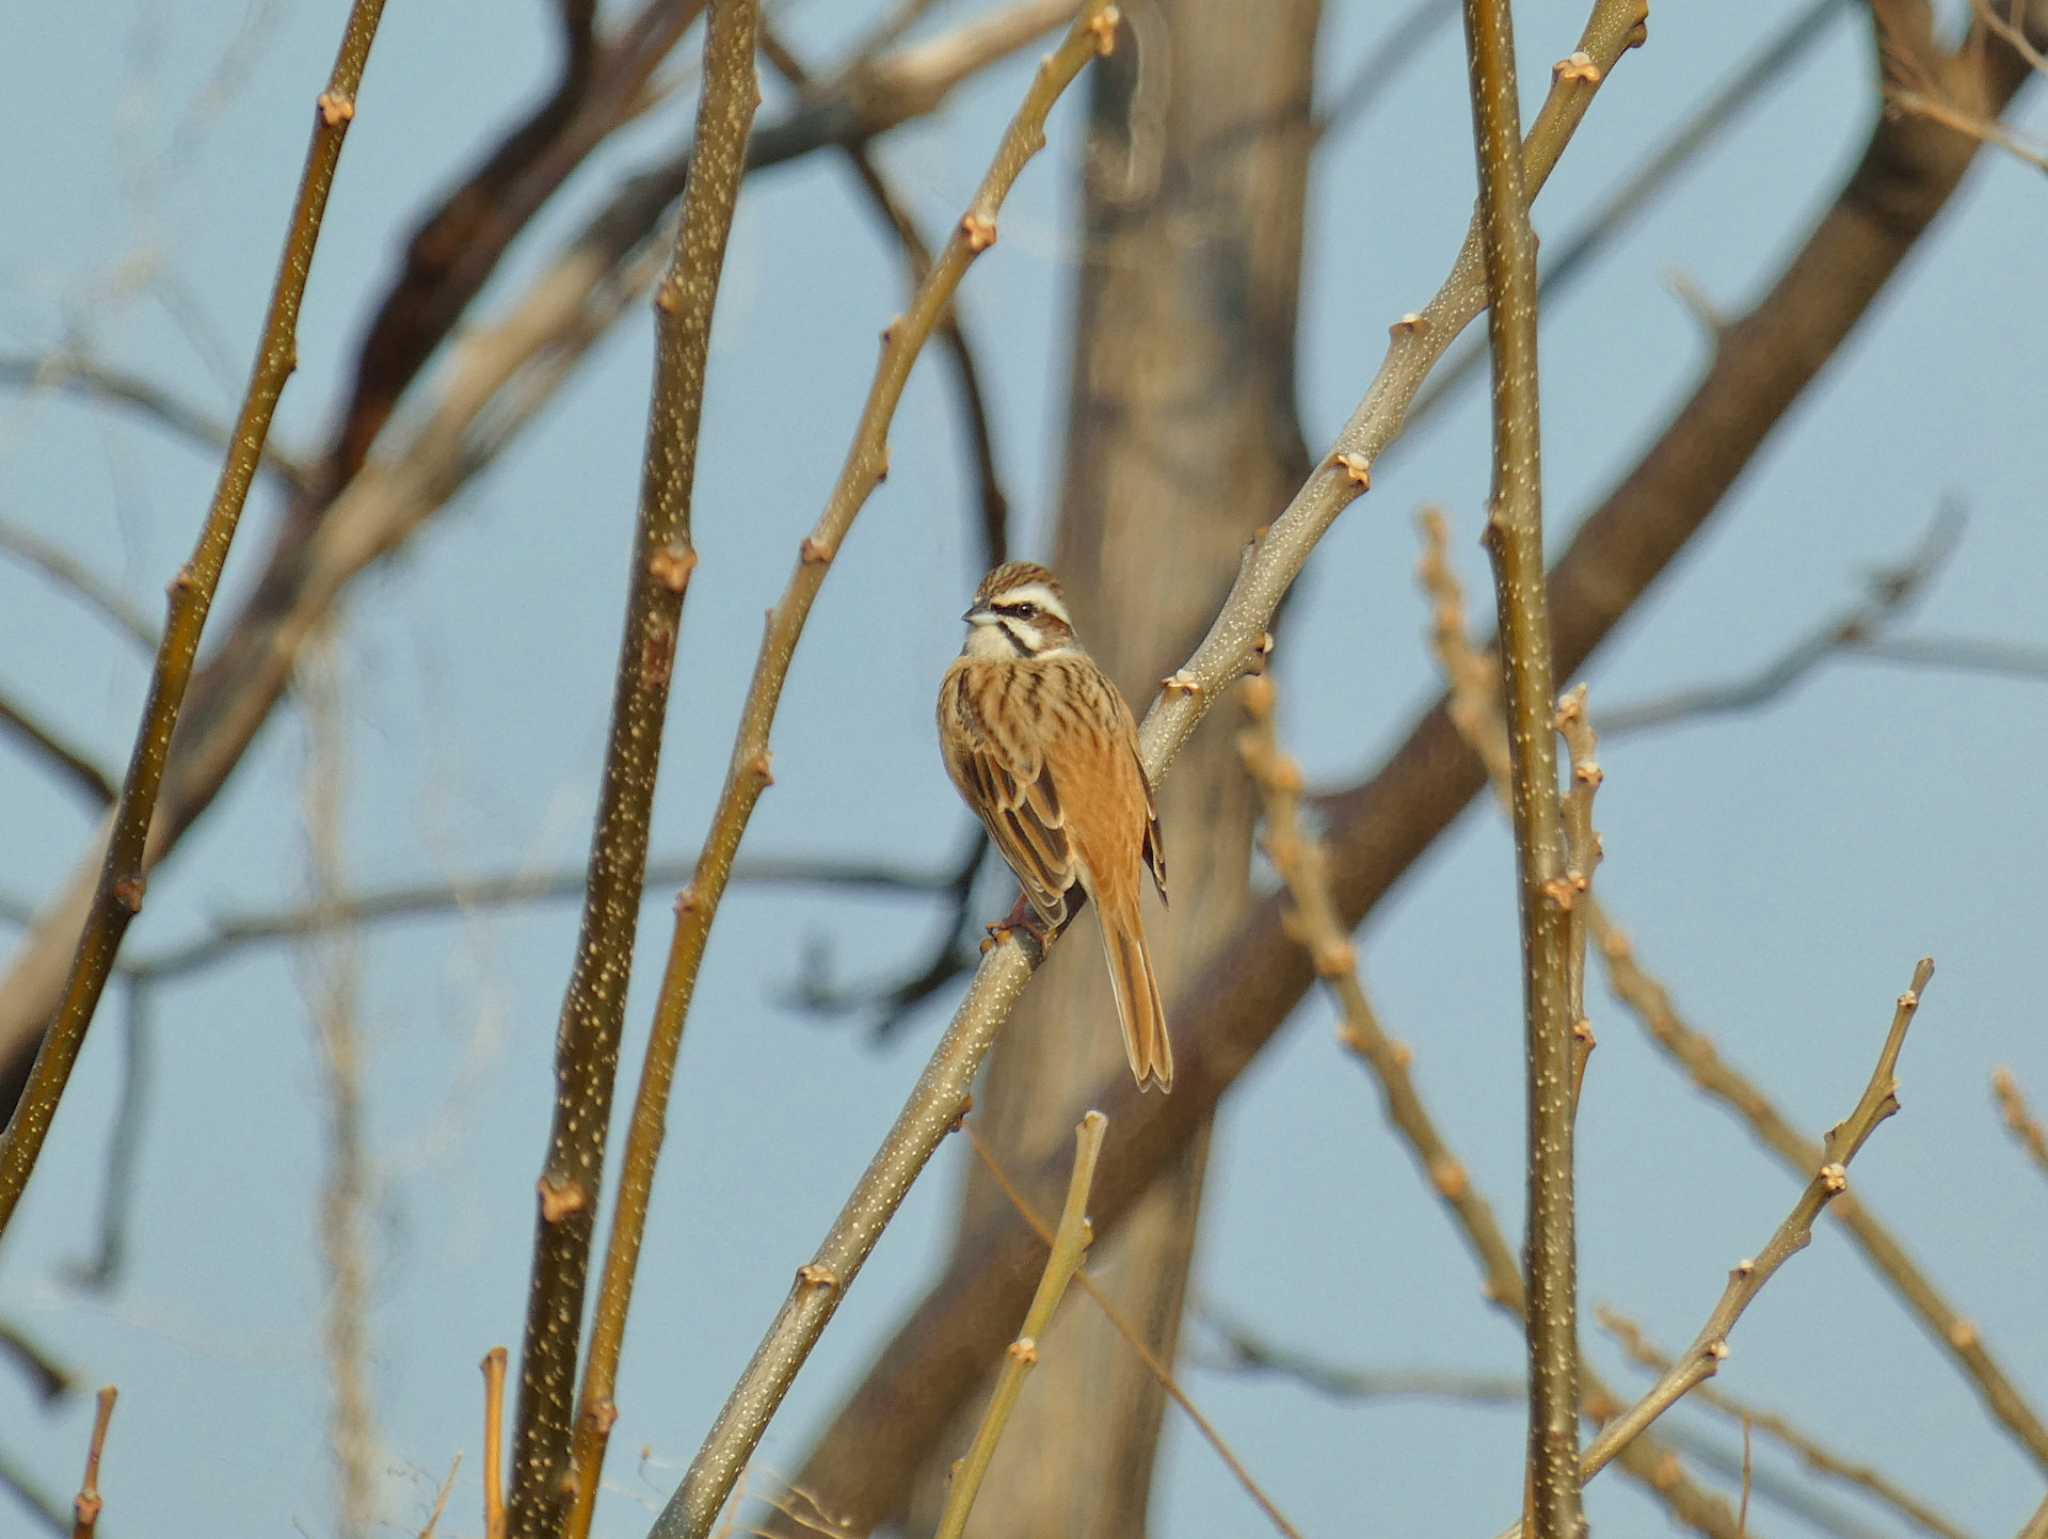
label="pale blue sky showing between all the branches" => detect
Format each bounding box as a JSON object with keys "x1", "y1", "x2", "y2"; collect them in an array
[{"x1": 0, "y1": 0, "x2": 2048, "y2": 1537}]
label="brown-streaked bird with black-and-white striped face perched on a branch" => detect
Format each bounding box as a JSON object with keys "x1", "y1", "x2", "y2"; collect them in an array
[{"x1": 938, "y1": 561, "x2": 1174, "y2": 1090}]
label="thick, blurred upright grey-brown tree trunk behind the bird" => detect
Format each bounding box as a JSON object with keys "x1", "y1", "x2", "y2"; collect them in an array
[{"x1": 911, "y1": 0, "x2": 1319, "y2": 1539}]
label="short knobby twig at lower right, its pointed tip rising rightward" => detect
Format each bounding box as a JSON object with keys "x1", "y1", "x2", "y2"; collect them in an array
[{"x1": 1509, "y1": 957, "x2": 1933, "y2": 1533}]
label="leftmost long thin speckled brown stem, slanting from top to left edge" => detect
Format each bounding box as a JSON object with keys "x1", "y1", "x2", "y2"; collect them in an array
[{"x1": 0, "y1": 0, "x2": 383, "y2": 1234}]
